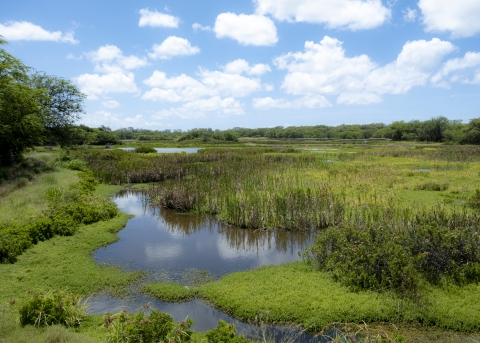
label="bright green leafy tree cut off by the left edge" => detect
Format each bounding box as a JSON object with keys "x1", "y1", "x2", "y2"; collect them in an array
[{"x1": 0, "y1": 37, "x2": 46, "y2": 159}]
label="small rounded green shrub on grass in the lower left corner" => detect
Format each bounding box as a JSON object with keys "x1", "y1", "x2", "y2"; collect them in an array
[{"x1": 19, "y1": 291, "x2": 85, "y2": 327}]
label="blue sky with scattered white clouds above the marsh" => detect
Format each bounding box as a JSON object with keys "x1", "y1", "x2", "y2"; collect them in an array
[{"x1": 0, "y1": 0, "x2": 480, "y2": 130}]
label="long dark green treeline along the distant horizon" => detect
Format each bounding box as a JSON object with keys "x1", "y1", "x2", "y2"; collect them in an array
[{"x1": 69, "y1": 117, "x2": 480, "y2": 145}]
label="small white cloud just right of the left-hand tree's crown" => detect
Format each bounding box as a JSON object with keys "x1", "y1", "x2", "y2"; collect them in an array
[{"x1": 74, "y1": 72, "x2": 138, "y2": 99}]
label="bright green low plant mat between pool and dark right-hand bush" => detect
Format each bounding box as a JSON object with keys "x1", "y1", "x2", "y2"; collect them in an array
[{"x1": 163, "y1": 262, "x2": 480, "y2": 332}]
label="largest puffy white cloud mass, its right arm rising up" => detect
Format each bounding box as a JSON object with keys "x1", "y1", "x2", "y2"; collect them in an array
[{"x1": 274, "y1": 36, "x2": 455, "y2": 104}]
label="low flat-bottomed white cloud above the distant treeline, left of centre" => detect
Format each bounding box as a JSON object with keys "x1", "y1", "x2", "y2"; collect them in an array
[{"x1": 154, "y1": 96, "x2": 245, "y2": 119}]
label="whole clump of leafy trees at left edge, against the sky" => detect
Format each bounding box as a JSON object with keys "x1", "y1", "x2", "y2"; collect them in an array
[{"x1": 0, "y1": 36, "x2": 85, "y2": 158}]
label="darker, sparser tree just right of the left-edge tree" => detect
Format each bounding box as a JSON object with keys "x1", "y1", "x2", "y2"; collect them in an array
[{"x1": 30, "y1": 73, "x2": 86, "y2": 147}]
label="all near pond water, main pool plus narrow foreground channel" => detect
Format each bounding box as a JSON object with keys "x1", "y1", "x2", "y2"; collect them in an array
[{"x1": 89, "y1": 191, "x2": 312, "y2": 340}]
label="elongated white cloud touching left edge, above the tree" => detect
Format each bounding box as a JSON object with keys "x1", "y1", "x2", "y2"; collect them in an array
[{"x1": 0, "y1": 21, "x2": 78, "y2": 44}]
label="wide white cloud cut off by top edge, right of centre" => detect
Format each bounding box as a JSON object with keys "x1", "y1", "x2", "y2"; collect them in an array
[{"x1": 254, "y1": 0, "x2": 391, "y2": 30}]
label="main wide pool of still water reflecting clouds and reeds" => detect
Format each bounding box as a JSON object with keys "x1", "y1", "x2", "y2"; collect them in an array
[{"x1": 94, "y1": 191, "x2": 311, "y2": 279}]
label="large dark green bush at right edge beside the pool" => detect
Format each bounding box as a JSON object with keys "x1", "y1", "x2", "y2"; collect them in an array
[{"x1": 305, "y1": 222, "x2": 480, "y2": 297}]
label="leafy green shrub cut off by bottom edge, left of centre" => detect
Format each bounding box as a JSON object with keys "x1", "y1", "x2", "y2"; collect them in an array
[{"x1": 103, "y1": 310, "x2": 193, "y2": 343}]
